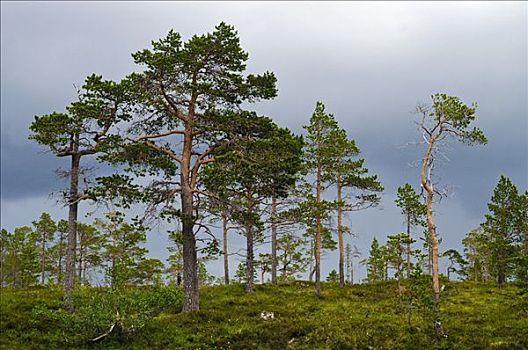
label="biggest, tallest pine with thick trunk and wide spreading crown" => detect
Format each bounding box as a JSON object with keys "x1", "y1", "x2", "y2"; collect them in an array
[{"x1": 95, "y1": 23, "x2": 277, "y2": 312}]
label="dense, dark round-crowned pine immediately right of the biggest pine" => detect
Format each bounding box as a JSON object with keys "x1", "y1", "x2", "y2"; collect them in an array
[{"x1": 203, "y1": 126, "x2": 302, "y2": 292}]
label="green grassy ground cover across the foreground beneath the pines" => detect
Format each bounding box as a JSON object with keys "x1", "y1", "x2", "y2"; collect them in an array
[{"x1": 0, "y1": 282, "x2": 528, "y2": 349}]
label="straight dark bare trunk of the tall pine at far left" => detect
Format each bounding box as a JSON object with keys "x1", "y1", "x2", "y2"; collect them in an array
[{"x1": 64, "y1": 152, "x2": 81, "y2": 312}]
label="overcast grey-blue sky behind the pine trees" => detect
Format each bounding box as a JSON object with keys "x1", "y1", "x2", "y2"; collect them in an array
[{"x1": 1, "y1": 1, "x2": 528, "y2": 282}]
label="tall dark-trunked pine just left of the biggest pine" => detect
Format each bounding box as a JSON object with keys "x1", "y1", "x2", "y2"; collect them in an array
[{"x1": 29, "y1": 74, "x2": 129, "y2": 311}]
